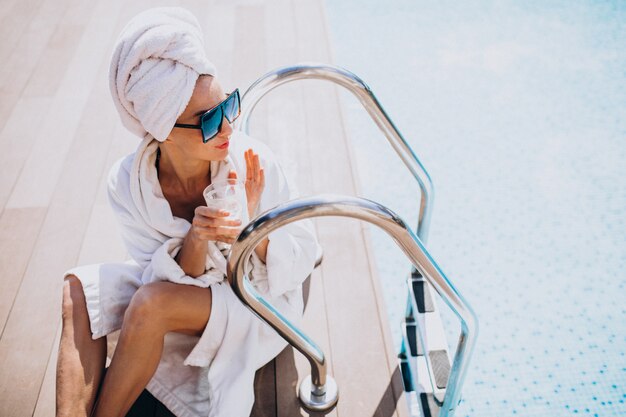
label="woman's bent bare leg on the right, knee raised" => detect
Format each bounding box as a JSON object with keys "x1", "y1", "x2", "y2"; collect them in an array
[{"x1": 95, "y1": 282, "x2": 212, "y2": 417}]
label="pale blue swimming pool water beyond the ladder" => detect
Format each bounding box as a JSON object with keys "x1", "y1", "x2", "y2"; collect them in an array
[{"x1": 326, "y1": 0, "x2": 626, "y2": 417}]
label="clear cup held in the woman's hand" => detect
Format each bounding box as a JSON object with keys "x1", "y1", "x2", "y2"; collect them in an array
[{"x1": 203, "y1": 179, "x2": 249, "y2": 226}]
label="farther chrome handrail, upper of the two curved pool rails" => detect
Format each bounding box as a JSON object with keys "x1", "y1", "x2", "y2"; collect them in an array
[{"x1": 235, "y1": 62, "x2": 434, "y2": 243}]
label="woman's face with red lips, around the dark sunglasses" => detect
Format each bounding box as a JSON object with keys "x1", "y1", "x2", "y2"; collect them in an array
[{"x1": 164, "y1": 75, "x2": 233, "y2": 161}]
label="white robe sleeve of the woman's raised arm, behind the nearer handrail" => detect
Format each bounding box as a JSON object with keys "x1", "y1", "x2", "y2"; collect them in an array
[{"x1": 245, "y1": 145, "x2": 321, "y2": 297}]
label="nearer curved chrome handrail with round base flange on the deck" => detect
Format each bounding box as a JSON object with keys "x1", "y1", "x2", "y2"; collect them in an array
[{"x1": 228, "y1": 194, "x2": 478, "y2": 417}]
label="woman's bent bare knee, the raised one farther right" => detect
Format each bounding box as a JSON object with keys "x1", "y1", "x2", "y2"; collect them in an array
[{"x1": 124, "y1": 282, "x2": 167, "y2": 328}]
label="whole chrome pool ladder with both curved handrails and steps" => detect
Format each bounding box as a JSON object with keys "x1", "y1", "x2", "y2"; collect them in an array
[{"x1": 229, "y1": 63, "x2": 478, "y2": 417}]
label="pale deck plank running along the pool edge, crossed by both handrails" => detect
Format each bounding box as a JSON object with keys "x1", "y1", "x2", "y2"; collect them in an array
[{"x1": 296, "y1": 2, "x2": 404, "y2": 416}]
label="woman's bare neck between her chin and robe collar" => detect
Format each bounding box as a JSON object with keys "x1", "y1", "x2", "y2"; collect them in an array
[{"x1": 157, "y1": 148, "x2": 211, "y2": 194}]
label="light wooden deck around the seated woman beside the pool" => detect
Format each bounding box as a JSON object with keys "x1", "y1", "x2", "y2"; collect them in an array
[{"x1": 0, "y1": 0, "x2": 408, "y2": 417}]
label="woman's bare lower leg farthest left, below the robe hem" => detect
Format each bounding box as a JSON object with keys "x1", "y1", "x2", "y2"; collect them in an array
[{"x1": 56, "y1": 275, "x2": 107, "y2": 417}]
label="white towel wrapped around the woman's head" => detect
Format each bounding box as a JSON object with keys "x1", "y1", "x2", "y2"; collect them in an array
[{"x1": 109, "y1": 7, "x2": 216, "y2": 142}]
